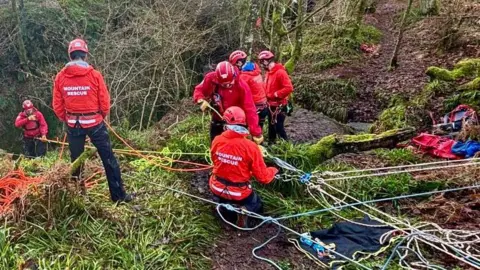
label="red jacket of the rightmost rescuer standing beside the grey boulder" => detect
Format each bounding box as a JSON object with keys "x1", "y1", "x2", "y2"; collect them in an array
[{"x1": 265, "y1": 63, "x2": 293, "y2": 106}]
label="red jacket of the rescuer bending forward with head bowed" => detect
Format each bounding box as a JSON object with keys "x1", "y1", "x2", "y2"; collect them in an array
[{"x1": 193, "y1": 72, "x2": 262, "y2": 136}]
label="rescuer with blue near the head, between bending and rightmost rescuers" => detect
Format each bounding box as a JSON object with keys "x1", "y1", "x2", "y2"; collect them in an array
[{"x1": 228, "y1": 50, "x2": 268, "y2": 129}]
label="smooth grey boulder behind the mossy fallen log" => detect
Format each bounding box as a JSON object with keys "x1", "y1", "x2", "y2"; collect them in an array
[{"x1": 282, "y1": 107, "x2": 352, "y2": 143}]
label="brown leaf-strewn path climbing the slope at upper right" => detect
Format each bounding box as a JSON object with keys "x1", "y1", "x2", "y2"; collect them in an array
[{"x1": 324, "y1": 0, "x2": 480, "y2": 122}]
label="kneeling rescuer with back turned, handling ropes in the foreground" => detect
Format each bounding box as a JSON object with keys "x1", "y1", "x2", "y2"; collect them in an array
[{"x1": 209, "y1": 106, "x2": 278, "y2": 226}]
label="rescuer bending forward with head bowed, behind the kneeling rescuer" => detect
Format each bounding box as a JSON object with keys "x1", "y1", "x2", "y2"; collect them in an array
[{"x1": 193, "y1": 61, "x2": 263, "y2": 144}]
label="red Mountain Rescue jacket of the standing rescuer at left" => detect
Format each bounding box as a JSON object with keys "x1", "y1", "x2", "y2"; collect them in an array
[{"x1": 52, "y1": 62, "x2": 110, "y2": 128}]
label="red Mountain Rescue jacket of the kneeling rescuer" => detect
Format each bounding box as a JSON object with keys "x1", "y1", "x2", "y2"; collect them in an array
[{"x1": 209, "y1": 130, "x2": 278, "y2": 201}]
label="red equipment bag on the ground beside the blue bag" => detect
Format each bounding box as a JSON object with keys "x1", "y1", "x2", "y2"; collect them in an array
[{"x1": 412, "y1": 133, "x2": 461, "y2": 159}]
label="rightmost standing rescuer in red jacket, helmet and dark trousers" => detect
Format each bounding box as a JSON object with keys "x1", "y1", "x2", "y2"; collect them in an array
[{"x1": 258, "y1": 51, "x2": 293, "y2": 143}]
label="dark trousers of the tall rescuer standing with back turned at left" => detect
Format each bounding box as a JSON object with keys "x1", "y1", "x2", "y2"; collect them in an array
[{"x1": 68, "y1": 122, "x2": 126, "y2": 201}]
